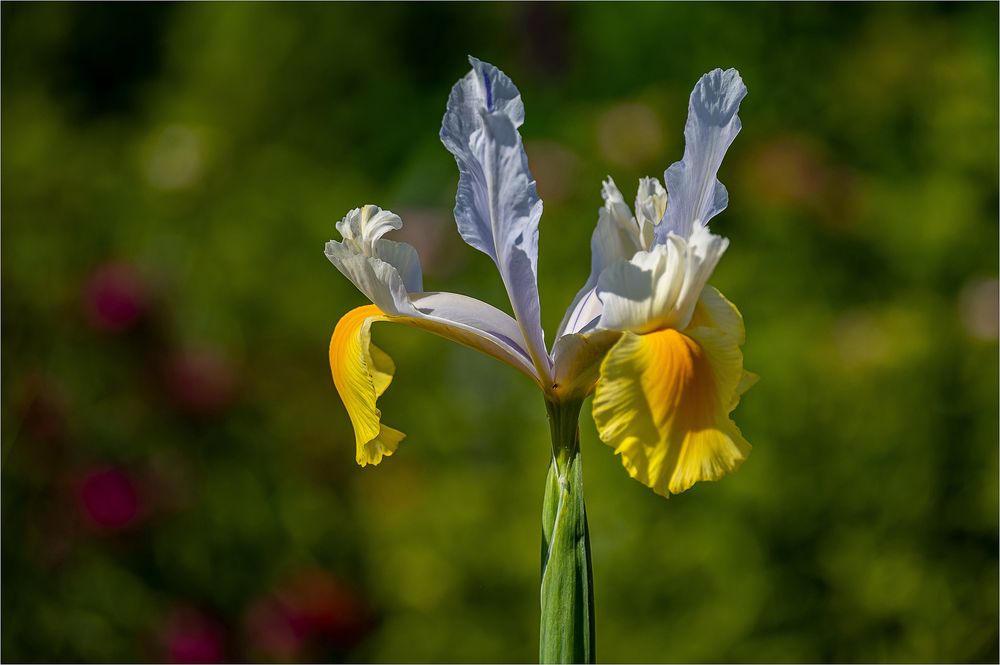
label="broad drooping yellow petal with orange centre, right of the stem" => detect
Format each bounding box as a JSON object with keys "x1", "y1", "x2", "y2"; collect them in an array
[{"x1": 593, "y1": 289, "x2": 753, "y2": 496}]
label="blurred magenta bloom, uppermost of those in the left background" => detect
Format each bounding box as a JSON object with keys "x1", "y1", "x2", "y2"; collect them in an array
[{"x1": 84, "y1": 263, "x2": 149, "y2": 332}]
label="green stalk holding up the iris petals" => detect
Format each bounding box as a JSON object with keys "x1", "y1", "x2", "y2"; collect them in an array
[{"x1": 538, "y1": 401, "x2": 595, "y2": 663}]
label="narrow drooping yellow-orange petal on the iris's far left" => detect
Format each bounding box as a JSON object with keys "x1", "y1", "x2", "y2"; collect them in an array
[{"x1": 330, "y1": 305, "x2": 406, "y2": 466}]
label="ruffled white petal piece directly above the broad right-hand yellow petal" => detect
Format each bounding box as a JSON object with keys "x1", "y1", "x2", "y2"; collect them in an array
[{"x1": 597, "y1": 227, "x2": 729, "y2": 334}]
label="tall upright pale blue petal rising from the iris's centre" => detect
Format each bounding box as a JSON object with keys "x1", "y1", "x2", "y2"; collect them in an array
[{"x1": 441, "y1": 58, "x2": 550, "y2": 375}]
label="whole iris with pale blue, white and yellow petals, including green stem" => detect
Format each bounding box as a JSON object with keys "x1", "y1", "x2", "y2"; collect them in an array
[{"x1": 326, "y1": 58, "x2": 756, "y2": 661}]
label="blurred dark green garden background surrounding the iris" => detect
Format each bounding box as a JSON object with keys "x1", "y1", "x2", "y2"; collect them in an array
[{"x1": 0, "y1": 3, "x2": 1000, "y2": 662}]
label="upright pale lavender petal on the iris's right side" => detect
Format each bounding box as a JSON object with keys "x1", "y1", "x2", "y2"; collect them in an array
[{"x1": 655, "y1": 69, "x2": 747, "y2": 244}]
